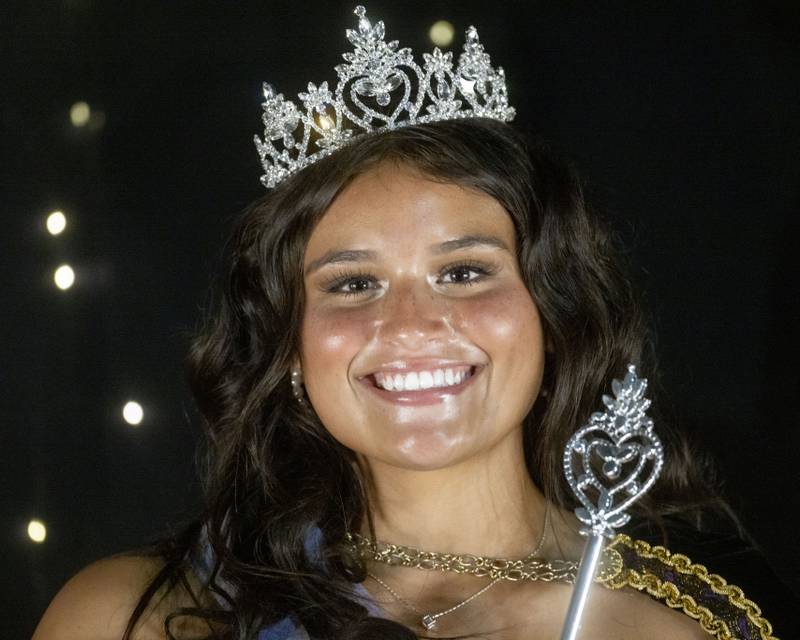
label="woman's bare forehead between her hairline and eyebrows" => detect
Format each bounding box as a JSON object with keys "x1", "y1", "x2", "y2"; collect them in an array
[{"x1": 306, "y1": 163, "x2": 516, "y2": 261}]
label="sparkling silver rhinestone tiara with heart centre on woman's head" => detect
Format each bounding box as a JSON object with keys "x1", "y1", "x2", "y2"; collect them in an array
[{"x1": 255, "y1": 5, "x2": 515, "y2": 189}]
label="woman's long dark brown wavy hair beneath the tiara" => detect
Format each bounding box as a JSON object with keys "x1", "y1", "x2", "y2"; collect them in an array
[{"x1": 123, "y1": 118, "x2": 722, "y2": 640}]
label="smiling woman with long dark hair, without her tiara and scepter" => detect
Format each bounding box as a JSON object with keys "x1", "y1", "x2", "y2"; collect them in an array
[{"x1": 34, "y1": 6, "x2": 788, "y2": 640}]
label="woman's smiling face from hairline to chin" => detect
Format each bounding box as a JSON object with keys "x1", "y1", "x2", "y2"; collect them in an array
[{"x1": 300, "y1": 164, "x2": 544, "y2": 470}]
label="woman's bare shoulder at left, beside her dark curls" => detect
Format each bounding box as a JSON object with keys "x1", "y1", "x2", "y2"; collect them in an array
[{"x1": 32, "y1": 555, "x2": 212, "y2": 640}]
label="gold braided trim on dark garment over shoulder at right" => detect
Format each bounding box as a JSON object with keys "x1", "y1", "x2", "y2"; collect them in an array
[{"x1": 598, "y1": 533, "x2": 778, "y2": 640}]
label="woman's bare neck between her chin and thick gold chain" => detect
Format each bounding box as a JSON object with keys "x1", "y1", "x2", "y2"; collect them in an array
[{"x1": 361, "y1": 430, "x2": 546, "y2": 558}]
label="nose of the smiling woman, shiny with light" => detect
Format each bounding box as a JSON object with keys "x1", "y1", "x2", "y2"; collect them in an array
[{"x1": 377, "y1": 281, "x2": 452, "y2": 351}]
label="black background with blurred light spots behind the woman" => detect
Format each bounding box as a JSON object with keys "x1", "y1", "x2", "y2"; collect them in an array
[{"x1": 0, "y1": 0, "x2": 800, "y2": 639}]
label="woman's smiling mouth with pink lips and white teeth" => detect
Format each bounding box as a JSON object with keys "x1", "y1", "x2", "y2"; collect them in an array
[{"x1": 360, "y1": 365, "x2": 484, "y2": 405}]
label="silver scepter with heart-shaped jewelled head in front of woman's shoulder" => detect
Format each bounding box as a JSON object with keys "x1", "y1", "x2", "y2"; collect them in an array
[{"x1": 561, "y1": 364, "x2": 664, "y2": 640}]
